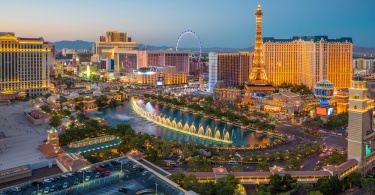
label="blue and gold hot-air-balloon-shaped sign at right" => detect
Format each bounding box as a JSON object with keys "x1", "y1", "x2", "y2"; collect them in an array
[{"x1": 314, "y1": 80, "x2": 335, "y2": 106}]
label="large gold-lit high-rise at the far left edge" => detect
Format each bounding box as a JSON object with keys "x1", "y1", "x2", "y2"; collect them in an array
[{"x1": 0, "y1": 32, "x2": 54, "y2": 99}]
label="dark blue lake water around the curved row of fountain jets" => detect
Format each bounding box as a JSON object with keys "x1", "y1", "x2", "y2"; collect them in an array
[{"x1": 91, "y1": 100, "x2": 277, "y2": 146}]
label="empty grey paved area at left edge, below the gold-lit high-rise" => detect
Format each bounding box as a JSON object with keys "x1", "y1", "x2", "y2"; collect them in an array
[{"x1": 0, "y1": 102, "x2": 50, "y2": 170}]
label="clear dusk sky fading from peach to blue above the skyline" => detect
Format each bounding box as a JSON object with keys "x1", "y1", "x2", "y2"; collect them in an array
[{"x1": 0, "y1": 0, "x2": 375, "y2": 48}]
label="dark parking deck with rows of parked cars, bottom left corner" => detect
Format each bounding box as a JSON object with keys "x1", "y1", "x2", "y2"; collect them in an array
[{"x1": 0, "y1": 158, "x2": 184, "y2": 195}]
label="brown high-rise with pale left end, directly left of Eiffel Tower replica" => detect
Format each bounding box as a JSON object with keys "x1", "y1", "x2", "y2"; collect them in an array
[{"x1": 209, "y1": 52, "x2": 252, "y2": 87}]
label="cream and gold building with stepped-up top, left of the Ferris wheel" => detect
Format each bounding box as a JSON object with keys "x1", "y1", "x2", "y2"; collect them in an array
[{"x1": 95, "y1": 31, "x2": 138, "y2": 58}]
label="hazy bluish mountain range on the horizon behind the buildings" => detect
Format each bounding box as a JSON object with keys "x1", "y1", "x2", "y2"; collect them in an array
[{"x1": 52, "y1": 40, "x2": 375, "y2": 55}]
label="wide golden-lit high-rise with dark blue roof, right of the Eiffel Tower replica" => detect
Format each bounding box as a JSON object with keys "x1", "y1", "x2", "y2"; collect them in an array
[{"x1": 263, "y1": 36, "x2": 353, "y2": 88}]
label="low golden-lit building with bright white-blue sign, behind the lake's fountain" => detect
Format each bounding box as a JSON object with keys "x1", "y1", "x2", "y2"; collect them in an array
[{"x1": 134, "y1": 66, "x2": 187, "y2": 86}]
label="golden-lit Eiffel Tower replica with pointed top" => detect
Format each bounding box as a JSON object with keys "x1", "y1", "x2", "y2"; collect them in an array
[{"x1": 242, "y1": 4, "x2": 273, "y2": 104}]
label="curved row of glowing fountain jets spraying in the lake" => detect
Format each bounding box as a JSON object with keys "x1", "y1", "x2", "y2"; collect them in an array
[{"x1": 131, "y1": 99, "x2": 233, "y2": 143}]
